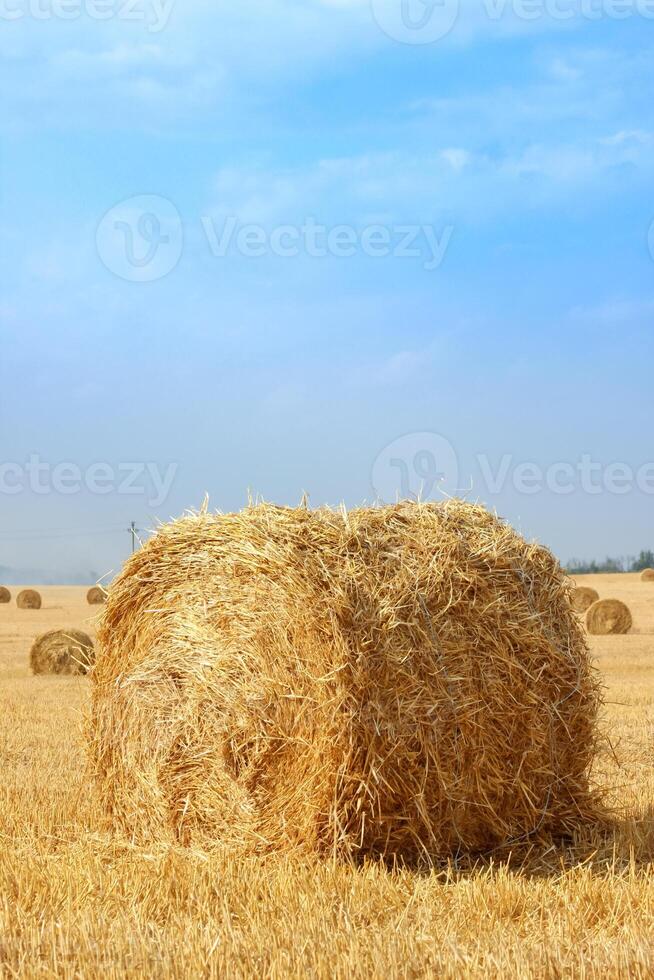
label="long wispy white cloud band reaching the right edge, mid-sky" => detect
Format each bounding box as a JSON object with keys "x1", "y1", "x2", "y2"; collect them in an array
[{"x1": 206, "y1": 120, "x2": 654, "y2": 232}]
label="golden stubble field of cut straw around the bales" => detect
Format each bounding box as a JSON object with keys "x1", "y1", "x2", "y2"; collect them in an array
[{"x1": 0, "y1": 575, "x2": 654, "y2": 978}]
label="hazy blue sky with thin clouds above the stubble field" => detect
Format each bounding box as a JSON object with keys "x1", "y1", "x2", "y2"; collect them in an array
[{"x1": 0, "y1": 0, "x2": 654, "y2": 577}]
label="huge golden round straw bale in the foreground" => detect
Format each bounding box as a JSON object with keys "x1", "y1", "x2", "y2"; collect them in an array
[{"x1": 88, "y1": 500, "x2": 600, "y2": 859}]
